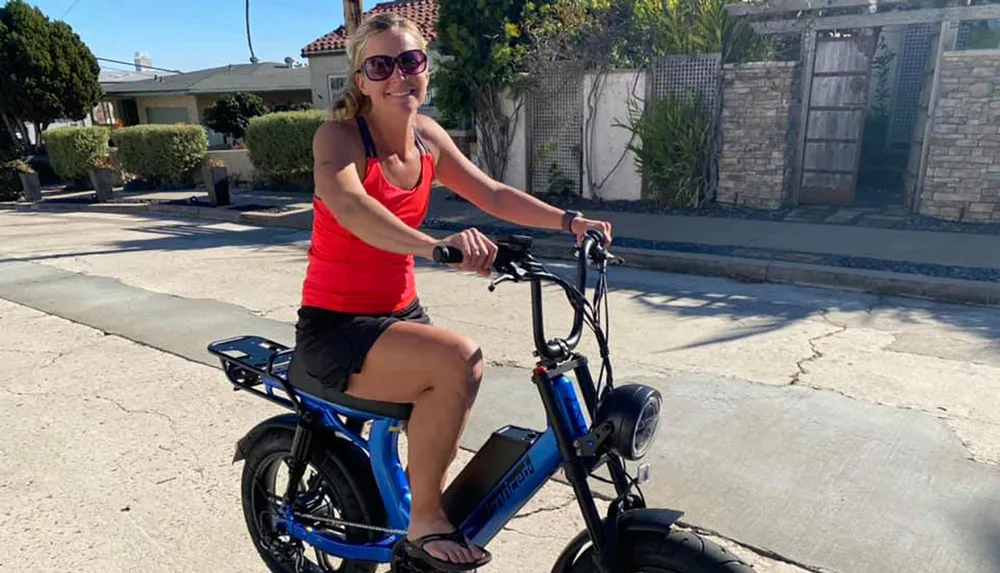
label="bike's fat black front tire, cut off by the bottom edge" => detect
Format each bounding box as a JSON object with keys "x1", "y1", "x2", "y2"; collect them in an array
[{"x1": 569, "y1": 529, "x2": 753, "y2": 573}]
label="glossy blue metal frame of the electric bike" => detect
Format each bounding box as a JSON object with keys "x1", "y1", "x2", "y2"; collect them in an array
[{"x1": 233, "y1": 348, "x2": 622, "y2": 563}]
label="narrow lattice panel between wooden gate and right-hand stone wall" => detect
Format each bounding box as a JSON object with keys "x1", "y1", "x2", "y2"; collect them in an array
[{"x1": 889, "y1": 24, "x2": 938, "y2": 143}]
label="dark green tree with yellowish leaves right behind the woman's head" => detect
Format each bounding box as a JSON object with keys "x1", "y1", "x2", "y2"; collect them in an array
[{"x1": 433, "y1": 0, "x2": 540, "y2": 179}]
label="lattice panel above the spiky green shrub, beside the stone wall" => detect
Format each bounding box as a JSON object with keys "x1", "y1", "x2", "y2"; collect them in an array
[{"x1": 652, "y1": 54, "x2": 722, "y2": 110}]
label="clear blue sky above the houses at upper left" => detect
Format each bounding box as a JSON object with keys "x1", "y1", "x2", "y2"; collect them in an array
[{"x1": 16, "y1": 0, "x2": 356, "y2": 72}]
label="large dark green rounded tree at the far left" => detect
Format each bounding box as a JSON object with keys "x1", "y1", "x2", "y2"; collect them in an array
[{"x1": 0, "y1": 0, "x2": 103, "y2": 137}]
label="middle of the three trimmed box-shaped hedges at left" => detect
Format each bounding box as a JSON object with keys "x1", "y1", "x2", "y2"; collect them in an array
[{"x1": 112, "y1": 125, "x2": 208, "y2": 185}]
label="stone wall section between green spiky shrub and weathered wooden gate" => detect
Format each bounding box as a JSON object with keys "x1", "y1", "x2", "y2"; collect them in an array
[{"x1": 716, "y1": 62, "x2": 802, "y2": 209}]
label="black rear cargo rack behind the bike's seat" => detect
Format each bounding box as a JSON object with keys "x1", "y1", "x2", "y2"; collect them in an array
[{"x1": 208, "y1": 335, "x2": 301, "y2": 411}]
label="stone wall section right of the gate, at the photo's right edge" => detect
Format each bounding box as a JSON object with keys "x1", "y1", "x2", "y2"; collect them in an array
[{"x1": 920, "y1": 50, "x2": 1000, "y2": 221}]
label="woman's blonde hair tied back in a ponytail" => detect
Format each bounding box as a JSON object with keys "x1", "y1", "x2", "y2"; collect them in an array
[{"x1": 331, "y1": 12, "x2": 427, "y2": 121}]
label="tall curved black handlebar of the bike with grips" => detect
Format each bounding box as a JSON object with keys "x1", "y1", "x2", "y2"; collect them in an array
[{"x1": 434, "y1": 230, "x2": 609, "y2": 360}]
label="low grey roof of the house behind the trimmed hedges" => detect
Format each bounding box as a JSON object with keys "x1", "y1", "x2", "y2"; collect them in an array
[{"x1": 101, "y1": 62, "x2": 312, "y2": 95}]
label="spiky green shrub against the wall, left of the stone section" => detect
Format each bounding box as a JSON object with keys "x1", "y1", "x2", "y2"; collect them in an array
[{"x1": 619, "y1": 92, "x2": 711, "y2": 208}]
